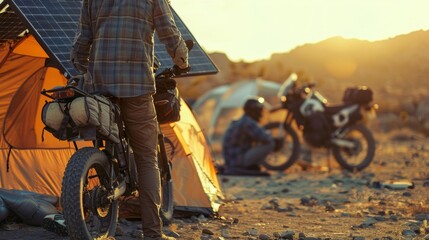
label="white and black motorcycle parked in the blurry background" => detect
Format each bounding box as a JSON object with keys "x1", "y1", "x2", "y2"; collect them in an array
[{"x1": 264, "y1": 74, "x2": 378, "y2": 171}]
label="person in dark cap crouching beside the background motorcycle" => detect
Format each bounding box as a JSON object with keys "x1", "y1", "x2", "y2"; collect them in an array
[{"x1": 222, "y1": 97, "x2": 276, "y2": 174}]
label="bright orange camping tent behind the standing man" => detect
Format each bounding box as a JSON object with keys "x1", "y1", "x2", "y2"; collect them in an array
[{"x1": 0, "y1": 36, "x2": 223, "y2": 216}]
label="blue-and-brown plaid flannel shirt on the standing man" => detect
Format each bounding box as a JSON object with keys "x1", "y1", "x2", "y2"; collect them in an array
[{"x1": 71, "y1": 0, "x2": 185, "y2": 97}]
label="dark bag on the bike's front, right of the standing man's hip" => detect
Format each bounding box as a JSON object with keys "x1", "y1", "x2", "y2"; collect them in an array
[{"x1": 153, "y1": 78, "x2": 180, "y2": 124}]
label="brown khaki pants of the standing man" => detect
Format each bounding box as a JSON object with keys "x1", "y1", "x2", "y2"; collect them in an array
[{"x1": 119, "y1": 95, "x2": 162, "y2": 237}]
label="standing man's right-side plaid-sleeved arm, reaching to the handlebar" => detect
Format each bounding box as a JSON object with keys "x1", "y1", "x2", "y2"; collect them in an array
[{"x1": 153, "y1": 0, "x2": 188, "y2": 69}]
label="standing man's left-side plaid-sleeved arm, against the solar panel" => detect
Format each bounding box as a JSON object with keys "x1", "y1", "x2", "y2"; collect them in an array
[{"x1": 70, "y1": 0, "x2": 92, "y2": 73}]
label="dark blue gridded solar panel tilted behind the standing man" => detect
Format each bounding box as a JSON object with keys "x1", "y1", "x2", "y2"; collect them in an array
[{"x1": 5, "y1": 0, "x2": 218, "y2": 76}]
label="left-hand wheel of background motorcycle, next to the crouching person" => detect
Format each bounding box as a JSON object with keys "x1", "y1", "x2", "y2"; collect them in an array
[{"x1": 264, "y1": 122, "x2": 301, "y2": 171}]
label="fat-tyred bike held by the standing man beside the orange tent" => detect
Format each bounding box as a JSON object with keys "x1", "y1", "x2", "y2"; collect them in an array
[{"x1": 42, "y1": 41, "x2": 193, "y2": 239}]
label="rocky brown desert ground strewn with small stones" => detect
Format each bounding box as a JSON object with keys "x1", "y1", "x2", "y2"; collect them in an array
[{"x1": 0, "y1": 129, "x2": 429, "y2": 240}]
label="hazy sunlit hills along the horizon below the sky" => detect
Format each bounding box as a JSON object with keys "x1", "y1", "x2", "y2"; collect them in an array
[{"x1": 179, "y1": 31, "x2": 429, "y2": 116}]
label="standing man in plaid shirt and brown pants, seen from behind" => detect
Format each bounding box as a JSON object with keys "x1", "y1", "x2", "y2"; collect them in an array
[{"x1": 71, "y1": 0, "x2": 189, "y2": 239}]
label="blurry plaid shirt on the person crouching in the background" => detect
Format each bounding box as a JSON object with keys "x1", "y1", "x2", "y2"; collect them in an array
[{"x1": 222, "y1": 114, "x2": 273, "y2": 167}]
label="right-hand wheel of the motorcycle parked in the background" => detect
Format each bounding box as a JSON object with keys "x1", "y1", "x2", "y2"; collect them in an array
[{"x1": 332, "y1": 125, "x2": 375, "y2": 172}]
